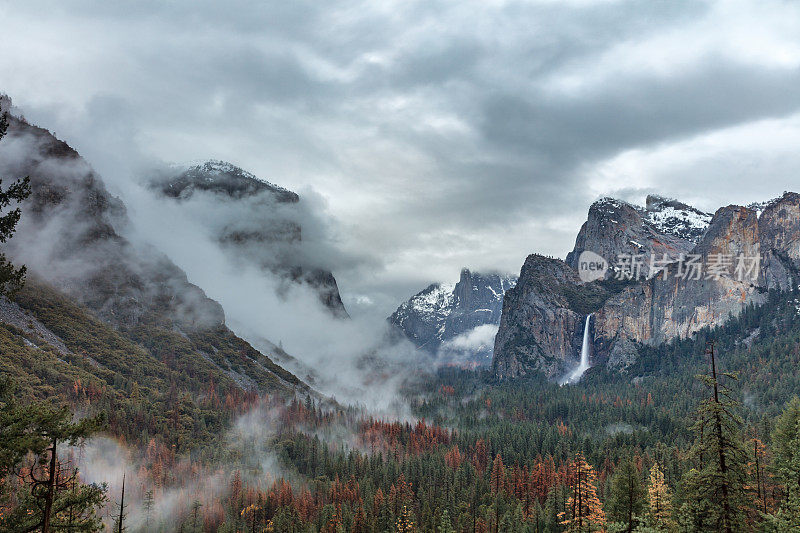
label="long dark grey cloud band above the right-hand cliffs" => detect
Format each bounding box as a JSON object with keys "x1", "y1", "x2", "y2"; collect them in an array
[{"x1": 481, "y1": 60, "x2": 800, "y2": 159}]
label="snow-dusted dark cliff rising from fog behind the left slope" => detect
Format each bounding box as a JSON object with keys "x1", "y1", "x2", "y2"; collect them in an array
[{"x1": 150, "y1": 161, "x2": 348, "y2": 318}]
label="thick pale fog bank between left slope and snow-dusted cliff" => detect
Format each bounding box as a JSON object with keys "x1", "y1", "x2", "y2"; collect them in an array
[{"x1": 121, "y1": 172, "x2": 426, "y2": 411}]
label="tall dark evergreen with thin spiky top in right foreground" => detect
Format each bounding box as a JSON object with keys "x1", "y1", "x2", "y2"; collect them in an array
[{"x1": 684, "y1": 343, "x2": 751, "y2": 533}]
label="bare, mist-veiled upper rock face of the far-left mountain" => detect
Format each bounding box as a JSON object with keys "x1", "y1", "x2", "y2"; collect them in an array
[{"x1": 0, "y1": 106, "x2": 225, "y2": 328}]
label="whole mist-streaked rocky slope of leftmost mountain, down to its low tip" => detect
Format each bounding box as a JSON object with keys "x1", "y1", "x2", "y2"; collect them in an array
[{"x1": 0, "y1": 100, "x2": 305, "y2": 393}]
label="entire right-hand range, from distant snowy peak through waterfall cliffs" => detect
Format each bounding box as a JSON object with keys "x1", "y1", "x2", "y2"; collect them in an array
[{"x1": 388, "y1": 193, "x2": 800, "y2": 379}]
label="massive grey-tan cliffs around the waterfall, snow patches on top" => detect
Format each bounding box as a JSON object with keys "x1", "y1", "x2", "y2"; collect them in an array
[{"x1": 494, "y1": 193, "x2": 800, "y2": 378}]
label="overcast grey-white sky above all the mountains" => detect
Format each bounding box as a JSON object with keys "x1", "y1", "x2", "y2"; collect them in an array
[{"x1": 0, "y1": 0, "x2": 800, "y2": 314}]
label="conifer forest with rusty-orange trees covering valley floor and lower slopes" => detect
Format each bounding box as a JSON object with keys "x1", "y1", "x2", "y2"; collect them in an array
[{"x1": 9, "y1": 272, "x2": 800, "y2": 532}]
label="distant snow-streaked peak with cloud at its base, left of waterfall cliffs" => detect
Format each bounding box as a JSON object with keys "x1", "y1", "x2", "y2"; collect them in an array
[{"x1": 388, "y1": 268, "x2": 516, "y2": 364}]
